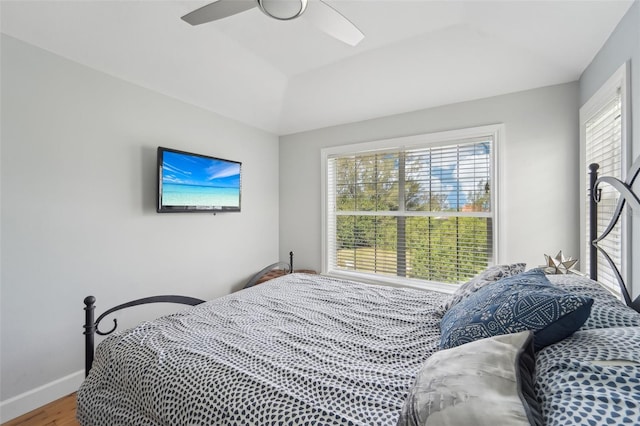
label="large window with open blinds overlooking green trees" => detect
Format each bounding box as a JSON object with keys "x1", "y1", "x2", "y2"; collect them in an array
[{"x1": 323, "y1": 126, "x2": 499, "y2": 290}]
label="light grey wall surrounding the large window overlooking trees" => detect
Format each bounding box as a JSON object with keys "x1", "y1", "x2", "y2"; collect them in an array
[{"x1": 280, "y1": 82, "x2": 579, "y2": 276}]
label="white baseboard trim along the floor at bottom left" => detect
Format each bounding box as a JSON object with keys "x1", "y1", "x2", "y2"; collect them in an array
[{"x1": 0, "y1": 370, "x2": 84, "y2": 423}]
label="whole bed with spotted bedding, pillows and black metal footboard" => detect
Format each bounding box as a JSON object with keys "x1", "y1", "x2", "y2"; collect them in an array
[{"x1": 77, "y1": 161, "x2": 640, "y2": 426}]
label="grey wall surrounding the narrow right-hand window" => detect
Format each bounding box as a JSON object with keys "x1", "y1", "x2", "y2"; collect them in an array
[{"x1": 580, "y1": 0, "x2": 640, "y2": 296}]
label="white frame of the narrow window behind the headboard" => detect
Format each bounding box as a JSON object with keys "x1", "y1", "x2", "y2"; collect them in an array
[{"x1": 579, "y1": 61, "x2": 632, "y2": 292}]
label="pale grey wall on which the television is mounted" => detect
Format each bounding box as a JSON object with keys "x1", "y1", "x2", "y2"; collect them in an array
[{"x1": 0, "y1": 35, "x2": 278, "y2": 421}]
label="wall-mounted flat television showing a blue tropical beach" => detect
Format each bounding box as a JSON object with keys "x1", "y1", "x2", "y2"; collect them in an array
[{"x1": 157, "y1": 147, "x2": 242, "y2": 213}]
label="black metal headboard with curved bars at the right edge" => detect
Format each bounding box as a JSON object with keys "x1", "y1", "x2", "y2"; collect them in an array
[{"x1": 589, "y1": 157, "x2": 640, "y2": 312}]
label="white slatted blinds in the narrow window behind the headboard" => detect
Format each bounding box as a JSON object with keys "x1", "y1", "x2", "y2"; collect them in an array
[{"x1": 583, "y1": 87, "x2": 623, "y2": 294}]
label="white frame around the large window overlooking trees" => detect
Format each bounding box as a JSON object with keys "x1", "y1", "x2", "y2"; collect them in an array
[{"x1": 321, "y1": 124, "x2": 505, "y2": 293}]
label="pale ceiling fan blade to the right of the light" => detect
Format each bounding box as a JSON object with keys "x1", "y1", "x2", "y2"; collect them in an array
[{"x1": 302, "y1": 0, "x2": 364, "y2": 46}]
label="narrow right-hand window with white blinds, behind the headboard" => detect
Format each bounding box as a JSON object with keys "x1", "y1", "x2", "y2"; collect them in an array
[{"x1": 580, "y1": 65, "x2": 628, "y2": 294}]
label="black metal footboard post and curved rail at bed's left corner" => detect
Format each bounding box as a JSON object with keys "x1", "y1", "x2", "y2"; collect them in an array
[{"x1": 83, "y1": 295, "x2": 204, "y2": 377}]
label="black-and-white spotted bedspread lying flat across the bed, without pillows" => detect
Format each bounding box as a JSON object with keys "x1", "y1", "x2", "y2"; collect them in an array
[{"x1": 78, "y1": 274, "x2": 447, "y2": 426}]
